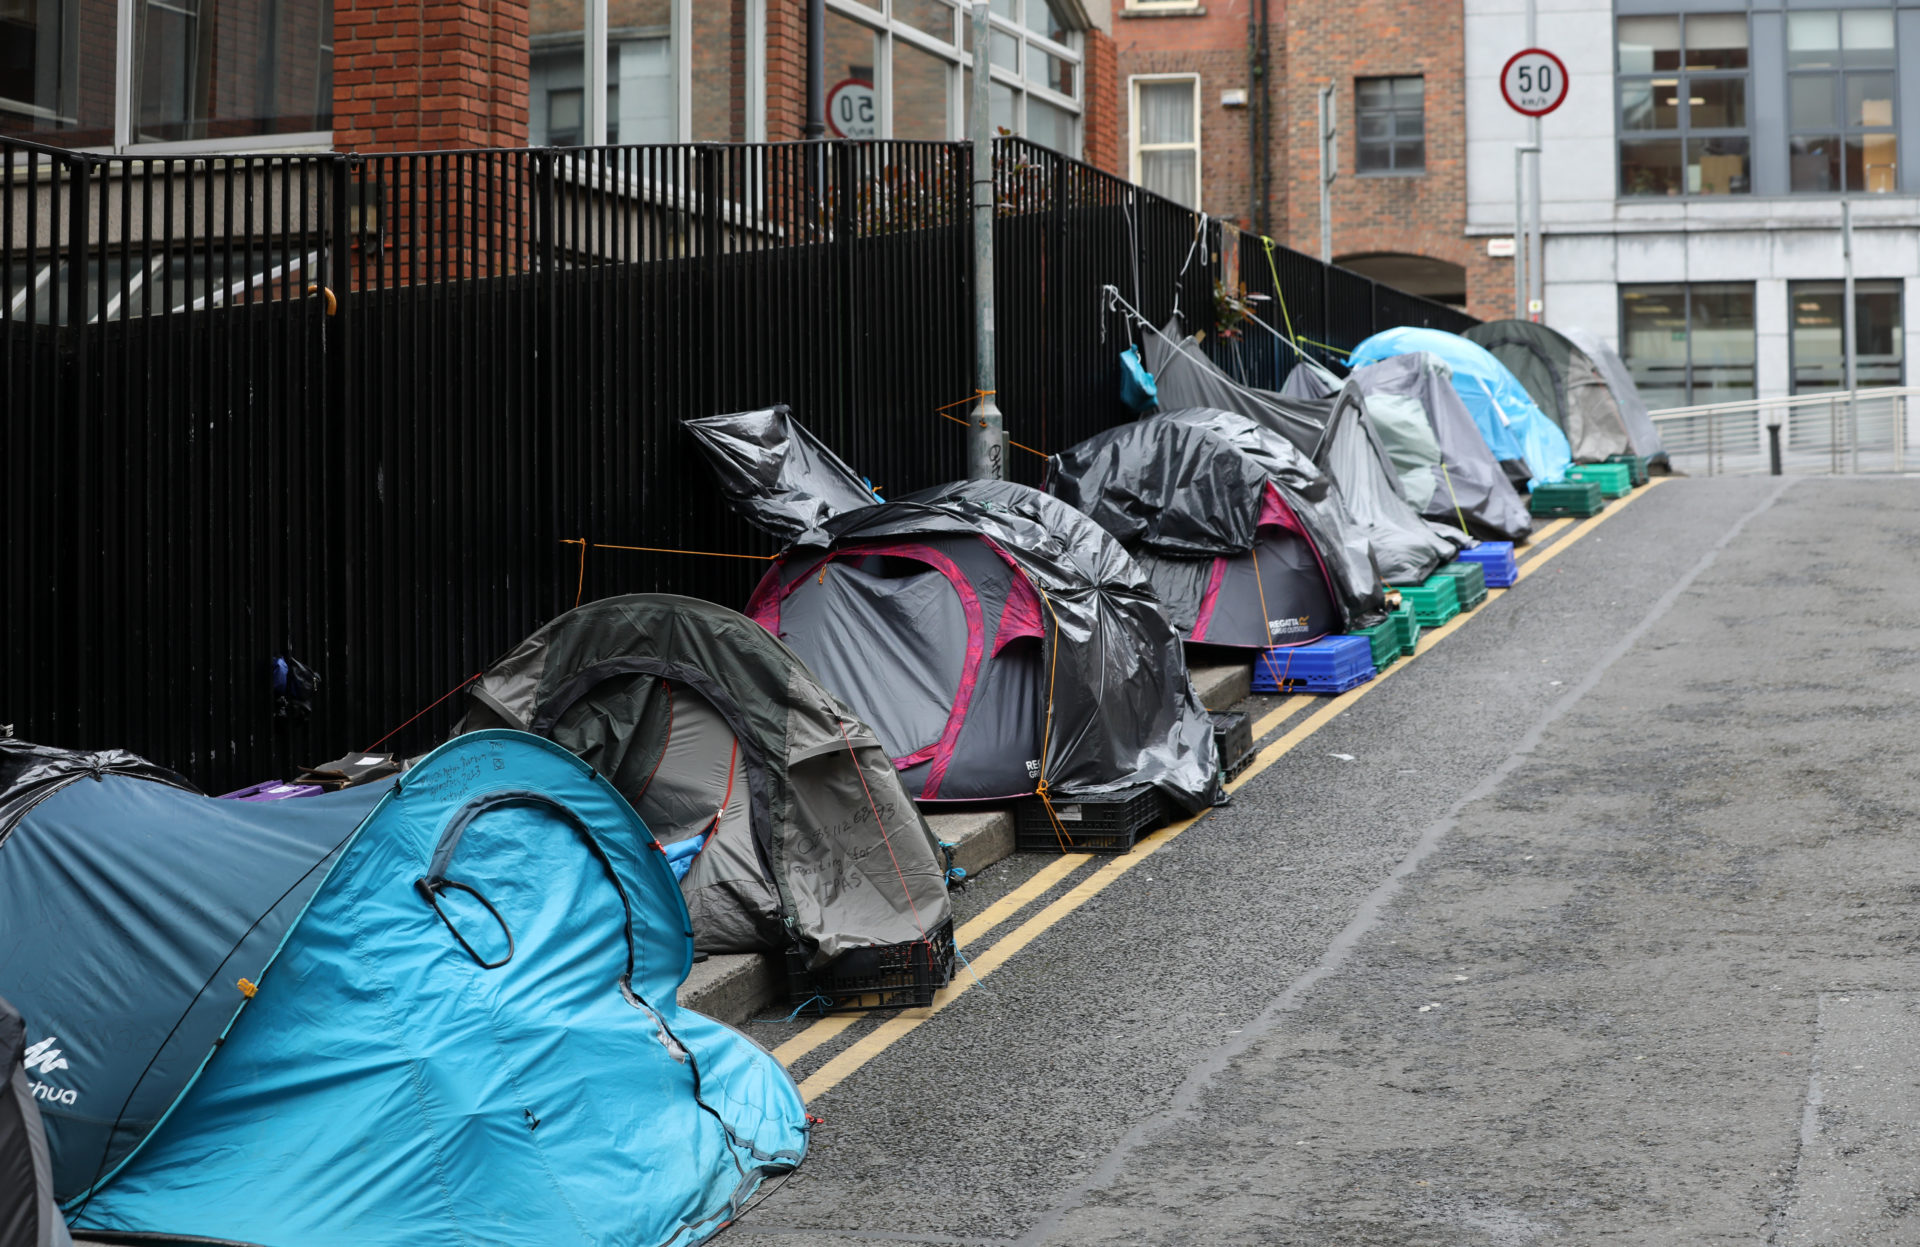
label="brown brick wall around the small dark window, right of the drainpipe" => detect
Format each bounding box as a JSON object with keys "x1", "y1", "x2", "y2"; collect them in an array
[{"x1": 1277, "y1": 0, "x2": 1513, "y2": 317}]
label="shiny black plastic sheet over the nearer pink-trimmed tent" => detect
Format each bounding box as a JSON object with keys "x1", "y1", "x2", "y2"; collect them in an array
[{"x1": 689, "y1": 413, "x2": 1215, "y2": 811}]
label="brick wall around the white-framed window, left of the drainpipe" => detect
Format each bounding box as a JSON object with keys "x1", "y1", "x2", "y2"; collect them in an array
[{"x1": 1114, "y1": 0, "x2": 1286, "y2": 236}]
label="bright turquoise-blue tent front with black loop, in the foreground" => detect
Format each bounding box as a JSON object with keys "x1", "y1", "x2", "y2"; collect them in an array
[{"x1": 0, "y1": 730, "x2": 808, "y2": 1247}]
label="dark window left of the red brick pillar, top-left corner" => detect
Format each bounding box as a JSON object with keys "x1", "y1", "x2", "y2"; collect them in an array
[{"x1": 0, "y1": 0, "x2": 334, "y2": 150}]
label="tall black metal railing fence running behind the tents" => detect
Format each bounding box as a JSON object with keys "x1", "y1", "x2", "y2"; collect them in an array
[{"x1": 0, "y1": 131, "x2": 1471, "y2": 790}]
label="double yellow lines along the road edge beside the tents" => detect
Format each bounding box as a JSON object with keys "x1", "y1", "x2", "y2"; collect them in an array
[{"x1": 774, "y1": 480, "x2": 1659, "y2": 1103}]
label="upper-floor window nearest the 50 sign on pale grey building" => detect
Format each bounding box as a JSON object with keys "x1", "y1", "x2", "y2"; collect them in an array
[{"x1": 1617, "y1": 13, "x2": 1753, "y2": 196}]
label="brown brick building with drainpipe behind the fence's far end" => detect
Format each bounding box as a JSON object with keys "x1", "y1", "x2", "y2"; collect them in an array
[{"x1": 1114, "y1": 0, "x2": 1513, "y2": 317}]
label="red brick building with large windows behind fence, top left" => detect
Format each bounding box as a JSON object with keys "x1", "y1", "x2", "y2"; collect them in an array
[{"x1": 0, "y1": 0, "x2": 1119, "y2": 169}]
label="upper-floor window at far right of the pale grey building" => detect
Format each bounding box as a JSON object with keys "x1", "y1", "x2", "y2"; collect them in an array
[{"x1": 1788, "y1": 10, "x2": 1899, "y2": 194}]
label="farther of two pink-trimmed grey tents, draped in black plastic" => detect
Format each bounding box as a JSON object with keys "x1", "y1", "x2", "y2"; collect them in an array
[{"x1": 1046, "y1": 407, "x2": 1386, "y2": 649}]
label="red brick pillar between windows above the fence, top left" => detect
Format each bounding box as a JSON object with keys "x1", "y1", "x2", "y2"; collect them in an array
[{"x1": 334, "y1": 0, "x2": 528, "y2": 152}]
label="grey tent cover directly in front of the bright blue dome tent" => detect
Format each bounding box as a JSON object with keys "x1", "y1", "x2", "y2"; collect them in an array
[{"x1": 1288, "y1": 352, "x2": 1534, "y2": 542}]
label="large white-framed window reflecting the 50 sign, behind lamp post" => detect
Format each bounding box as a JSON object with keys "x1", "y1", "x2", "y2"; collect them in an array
[{"x1": 826, "y1": 0, "x2": 1081, "y2": 156}]
